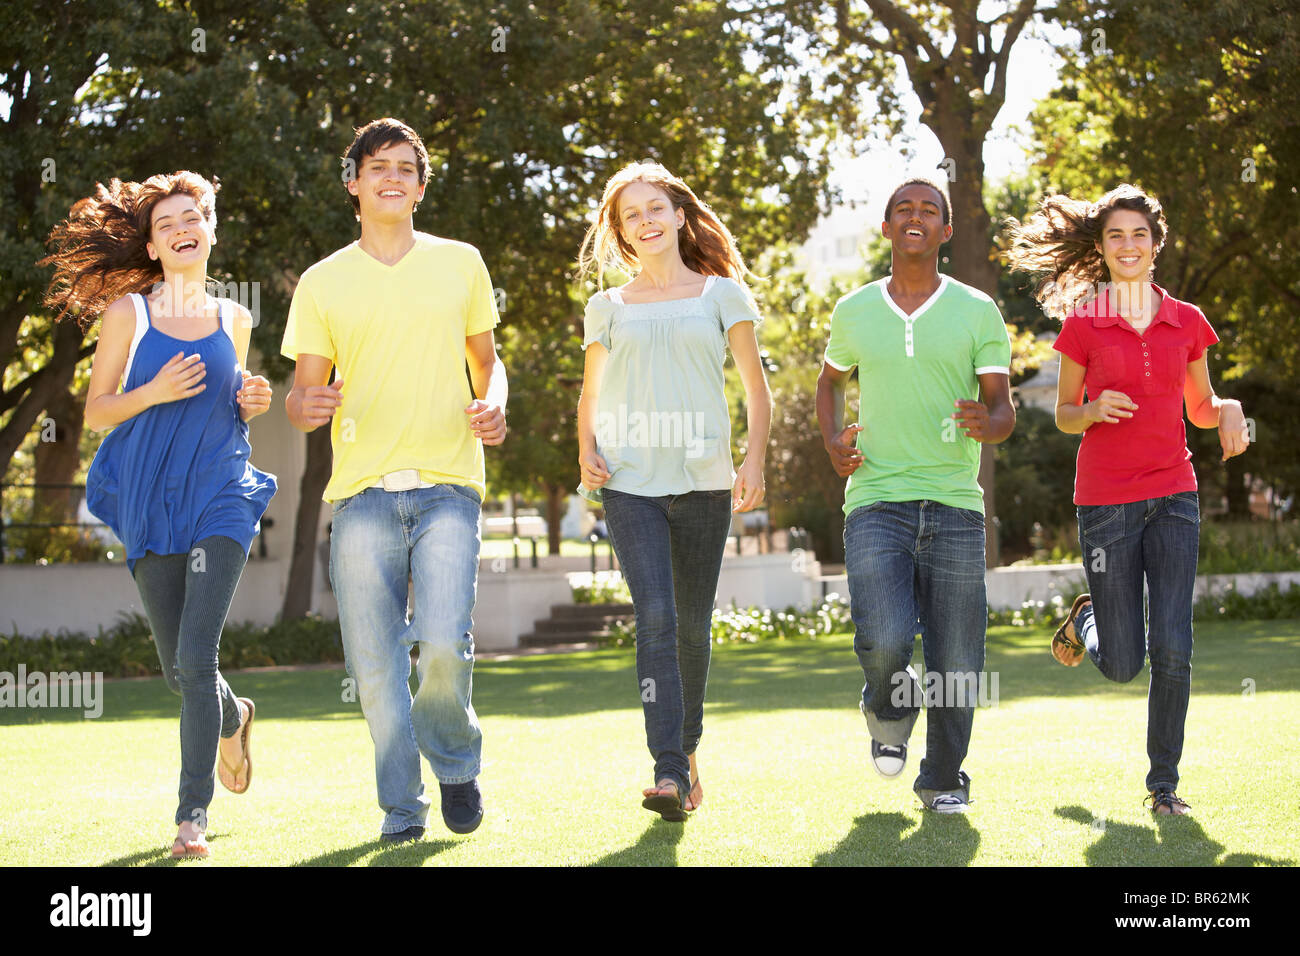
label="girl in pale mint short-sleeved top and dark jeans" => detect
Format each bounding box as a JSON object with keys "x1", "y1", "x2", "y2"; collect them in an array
[{"x1": 577, "y1": 164, "x2": 772, "y2": 821}]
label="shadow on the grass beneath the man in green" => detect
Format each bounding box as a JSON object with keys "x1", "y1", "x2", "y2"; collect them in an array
[{"x1": 813, "y1": 812, "x2": 979, "y2": 866}]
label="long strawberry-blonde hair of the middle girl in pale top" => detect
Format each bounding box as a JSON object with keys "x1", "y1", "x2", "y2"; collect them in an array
[{"x1": 579, "y1": 163, "x2": 754, "y2": 289}]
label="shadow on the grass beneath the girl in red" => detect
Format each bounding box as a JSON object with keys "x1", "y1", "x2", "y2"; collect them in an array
[{"x1": 1054, "y1": 805, "x2": 1295, "y2": 866}]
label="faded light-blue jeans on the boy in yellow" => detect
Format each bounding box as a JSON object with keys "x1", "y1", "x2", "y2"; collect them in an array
[{"x1": 329, "y1": 484, "x2": 482, "y2": 832}]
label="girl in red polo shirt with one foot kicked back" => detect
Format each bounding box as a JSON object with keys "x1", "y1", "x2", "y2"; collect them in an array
[{"x1": 1010, "y1": 185, "x2": 1247, "y2": 814}]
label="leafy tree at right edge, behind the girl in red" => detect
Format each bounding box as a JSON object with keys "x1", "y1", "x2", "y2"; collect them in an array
[{"x1": 1032, "y1": 0, "x2": 1300, "y2": 514}]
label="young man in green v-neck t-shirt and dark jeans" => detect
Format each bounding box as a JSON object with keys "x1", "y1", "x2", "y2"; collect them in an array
[{"x1": 816, "y1": 179, "x2": 1015, "y2": 813}]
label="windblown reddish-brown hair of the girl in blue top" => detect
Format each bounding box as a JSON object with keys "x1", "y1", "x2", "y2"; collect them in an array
[{"x1": 36, "y1": 170, "x2": 220, "y2": 328}]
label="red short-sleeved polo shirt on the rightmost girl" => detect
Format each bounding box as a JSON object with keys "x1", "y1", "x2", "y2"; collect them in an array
[{"x1": 1053, "y1": 286, "x2": 1218, "y2": 505}]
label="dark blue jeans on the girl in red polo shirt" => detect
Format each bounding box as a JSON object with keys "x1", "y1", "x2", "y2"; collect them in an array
[{"x1": 1075, "y1": 492, "x2": 1201, "y2": 790}]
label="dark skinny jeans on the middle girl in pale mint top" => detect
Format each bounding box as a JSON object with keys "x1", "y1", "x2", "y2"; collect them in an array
[{"x1": 602, "y1": 489, "x2": 732, "y2": 796}]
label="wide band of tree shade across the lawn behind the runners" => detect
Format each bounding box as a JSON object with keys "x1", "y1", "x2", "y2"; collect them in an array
[{"x1": 0, "y1": 620, "x2": 1300, "y2": 726}]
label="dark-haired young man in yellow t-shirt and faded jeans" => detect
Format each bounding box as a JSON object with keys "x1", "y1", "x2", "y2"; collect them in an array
[{"x1": 282, "y1": 118, "x2": 507, "y2": 843}]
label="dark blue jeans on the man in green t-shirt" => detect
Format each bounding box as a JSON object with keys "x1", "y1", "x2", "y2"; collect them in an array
[{"x1": 844, "y1": 501, "x2": 988, "y2": 790}]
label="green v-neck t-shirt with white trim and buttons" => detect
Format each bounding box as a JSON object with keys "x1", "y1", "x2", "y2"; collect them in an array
[{"x1": 826, "y1": 276, "x2": 1011, "y2": 515}]
